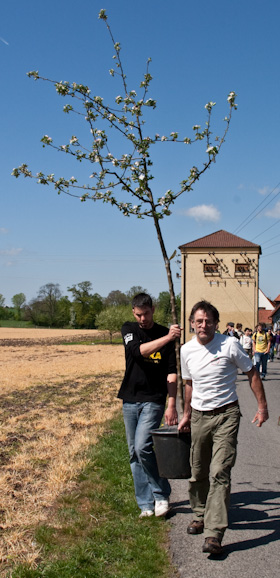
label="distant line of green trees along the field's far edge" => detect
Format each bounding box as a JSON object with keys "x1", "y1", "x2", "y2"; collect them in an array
[{"x1": 0, "y1": 281, "x2": 180, "y2": 337}]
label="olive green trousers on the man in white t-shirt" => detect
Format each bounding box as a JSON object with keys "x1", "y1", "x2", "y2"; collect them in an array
[{"x1": 189, "y1": 405, "x2": 241, "y2": 540}]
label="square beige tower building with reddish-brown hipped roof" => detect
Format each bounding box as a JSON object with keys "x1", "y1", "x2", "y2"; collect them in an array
[{"x1": 179, "y1": 230, "x2": 261, "y2": 342}]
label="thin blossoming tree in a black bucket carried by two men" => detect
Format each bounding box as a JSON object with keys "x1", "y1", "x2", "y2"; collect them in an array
[{"x1": 12, "y1": 10, "x2": 237, "y2": 404}]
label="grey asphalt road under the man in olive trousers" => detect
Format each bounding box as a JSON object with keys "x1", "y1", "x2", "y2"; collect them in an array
[{"x1": 169, "y1": 360, "x2": 280, "y2": 578}]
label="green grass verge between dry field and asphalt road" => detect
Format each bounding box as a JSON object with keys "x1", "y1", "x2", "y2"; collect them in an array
[{"x1": 12, "y1": 417, "x2": 175, "y2": 578}]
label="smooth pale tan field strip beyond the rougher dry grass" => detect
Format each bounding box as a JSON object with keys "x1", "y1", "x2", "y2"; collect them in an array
[{"x1": 0, "y1": 327, "x2": 124, "y2": 393}]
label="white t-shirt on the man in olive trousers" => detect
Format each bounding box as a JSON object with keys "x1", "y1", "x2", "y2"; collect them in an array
[{"x1": 181, "y1": 333, "x2": 253, "y2": 411}]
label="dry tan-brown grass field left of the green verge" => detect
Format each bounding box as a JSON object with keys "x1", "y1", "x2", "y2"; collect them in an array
[{"x1": 0, "y1": 328, "x2": 124, "y2": 576}]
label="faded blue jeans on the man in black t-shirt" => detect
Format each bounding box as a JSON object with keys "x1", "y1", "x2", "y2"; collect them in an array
[{"x1": 123, "y1": 402, "x2": 171, "y2": 511}]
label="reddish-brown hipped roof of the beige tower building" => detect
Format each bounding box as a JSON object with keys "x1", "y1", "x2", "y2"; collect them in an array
[{"x1": 179, "y1": 229, "x2": 261, "y2": 254}]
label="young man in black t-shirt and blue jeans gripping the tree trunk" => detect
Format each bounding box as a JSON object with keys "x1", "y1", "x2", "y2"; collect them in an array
[{"x1": 118, "y1": 293, "x2": 181, "y2": 518}]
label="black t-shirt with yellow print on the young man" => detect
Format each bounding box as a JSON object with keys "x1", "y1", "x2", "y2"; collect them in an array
[{"x1": 118, "y1": 321, "x2": 177, "y2": 404}]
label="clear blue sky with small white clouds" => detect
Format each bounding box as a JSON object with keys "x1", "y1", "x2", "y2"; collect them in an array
[{"x1": 0, "y1": 0, "x2": 280, "y2": 305}]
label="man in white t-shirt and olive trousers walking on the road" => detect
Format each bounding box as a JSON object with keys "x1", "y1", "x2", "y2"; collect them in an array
[{"x1": 178, "y1": 301, "x2": 268, "y2": 554}]
